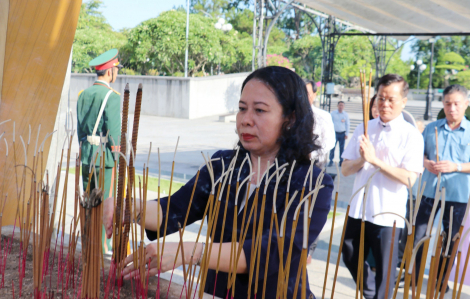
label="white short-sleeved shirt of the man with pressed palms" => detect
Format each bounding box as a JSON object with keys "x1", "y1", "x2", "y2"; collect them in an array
[{"x1": 342, "y1": 114, "x2": 424, "y2": 228}]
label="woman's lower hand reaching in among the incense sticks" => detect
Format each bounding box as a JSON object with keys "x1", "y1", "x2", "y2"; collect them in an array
[{"x1": 122, "y1": 241, "x2": 202, "y2": 279}]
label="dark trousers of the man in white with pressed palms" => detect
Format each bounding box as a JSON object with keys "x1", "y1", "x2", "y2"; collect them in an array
[{"x1": 342, "y1": 217, "x2": 401, "y2": 299}]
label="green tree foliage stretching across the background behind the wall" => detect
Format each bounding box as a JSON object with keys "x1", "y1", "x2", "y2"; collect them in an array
[{"x1": 73, "y1": 0, "x2": 414, "y2": 82}]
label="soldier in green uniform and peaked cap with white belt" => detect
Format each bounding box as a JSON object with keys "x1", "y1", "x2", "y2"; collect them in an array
[{"x1": 77, "y1": 49, "x2": 122, "y2": 253}]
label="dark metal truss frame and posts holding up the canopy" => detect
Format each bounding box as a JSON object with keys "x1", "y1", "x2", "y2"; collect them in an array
[{"x1": 252, "y1": 0, "x2": 470, "y2": 118}]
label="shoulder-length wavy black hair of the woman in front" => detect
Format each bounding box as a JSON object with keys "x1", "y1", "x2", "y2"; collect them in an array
[{"x1": 238, "y1": 66, "x2": 321, "y2": 165}]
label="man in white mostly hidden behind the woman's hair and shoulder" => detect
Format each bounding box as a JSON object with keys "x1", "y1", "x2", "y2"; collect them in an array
[{"x1": 305, "y1": 81, "x2": 336, "y2": 168}]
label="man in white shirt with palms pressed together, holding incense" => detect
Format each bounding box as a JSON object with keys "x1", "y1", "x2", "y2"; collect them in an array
[{"x1": 341, "y1": 74, "x2": 424, "y2": 299}]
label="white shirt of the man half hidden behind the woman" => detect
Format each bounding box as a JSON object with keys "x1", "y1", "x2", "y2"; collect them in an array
[{"x1": 310, "y1": 105, "x2": 336, "y2": 167}]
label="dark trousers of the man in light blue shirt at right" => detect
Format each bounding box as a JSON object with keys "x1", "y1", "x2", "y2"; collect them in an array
[{"x1": 414, "y1": 196, "x2": 467, "y2": 283}]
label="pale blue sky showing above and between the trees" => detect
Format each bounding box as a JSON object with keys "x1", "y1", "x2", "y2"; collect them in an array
[{"x1": 97, "y1": 0, "x2": 413, "y2": 61}]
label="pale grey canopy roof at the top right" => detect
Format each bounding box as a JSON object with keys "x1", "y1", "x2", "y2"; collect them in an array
[{"x1": 298, "y1": 0, "x2": 470, "y2": 36}]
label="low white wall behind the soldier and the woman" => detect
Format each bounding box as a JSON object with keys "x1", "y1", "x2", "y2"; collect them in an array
[{"x1": 70, "y1": 73, "x2": 249, "y2": 119}]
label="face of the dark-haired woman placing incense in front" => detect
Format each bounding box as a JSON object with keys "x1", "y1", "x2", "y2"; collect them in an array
[{"x1": 237, "y1": 79, "x2": 286, "y2": 156}]
